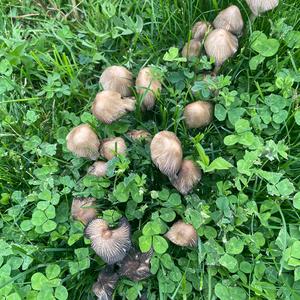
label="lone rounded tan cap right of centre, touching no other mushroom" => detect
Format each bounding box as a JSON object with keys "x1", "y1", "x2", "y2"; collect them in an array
[{"x1": 183, "y1": 101, "x2": 213, "y2": 128}]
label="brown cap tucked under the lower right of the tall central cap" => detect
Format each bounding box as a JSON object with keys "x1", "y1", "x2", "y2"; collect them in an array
[{"x1": 171, "y1": 159, "x2": 201, "y2": 195}]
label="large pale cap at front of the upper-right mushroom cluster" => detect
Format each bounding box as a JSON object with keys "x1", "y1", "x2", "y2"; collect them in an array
[{"x1": 204, "y1": 29, "x2": 238, "y2": 66}]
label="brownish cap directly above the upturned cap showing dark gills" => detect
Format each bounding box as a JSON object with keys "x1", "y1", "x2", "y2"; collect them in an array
[{"x1": 71, "y1": 198, "x2": 97, "y2": 224}]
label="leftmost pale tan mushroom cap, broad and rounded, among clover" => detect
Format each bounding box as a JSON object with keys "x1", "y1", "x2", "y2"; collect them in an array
[{"x1": 66, "y1": 124, "x2": 100, "y2": 160}]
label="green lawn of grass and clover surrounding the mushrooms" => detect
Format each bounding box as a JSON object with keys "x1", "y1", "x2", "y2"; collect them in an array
[{"x1": 0, "y1": 0, "x2": 300, "y2": 300}]
